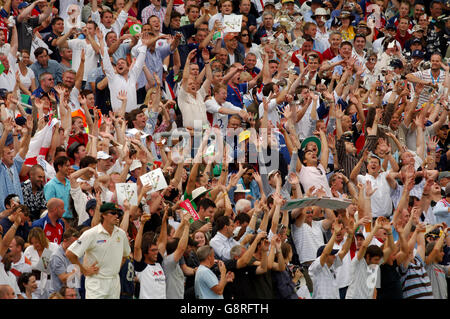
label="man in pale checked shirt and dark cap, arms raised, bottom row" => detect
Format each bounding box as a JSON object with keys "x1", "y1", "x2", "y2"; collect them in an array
[{"x1": 308, "y1": 221, "x2": 353, "y2": 299}]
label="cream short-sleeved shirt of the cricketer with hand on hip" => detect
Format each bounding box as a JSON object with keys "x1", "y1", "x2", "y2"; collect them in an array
[{"x1": 69, "y1": 224, "x2": 131, "y2": 279}]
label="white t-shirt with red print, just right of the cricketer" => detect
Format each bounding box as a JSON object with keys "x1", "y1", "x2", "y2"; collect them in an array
[{"x1": 136, "y1": 263, "x2": 166, "y2": 299}]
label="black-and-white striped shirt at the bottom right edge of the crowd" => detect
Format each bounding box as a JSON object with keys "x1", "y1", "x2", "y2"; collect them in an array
[{"x1": 399, "y1": 255, "x2": 433, "y2": 299}]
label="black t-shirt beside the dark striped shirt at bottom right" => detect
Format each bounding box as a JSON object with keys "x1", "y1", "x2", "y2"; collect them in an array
[{"x1": 377, "y1": 260, "x2": 403, "y2": 299}]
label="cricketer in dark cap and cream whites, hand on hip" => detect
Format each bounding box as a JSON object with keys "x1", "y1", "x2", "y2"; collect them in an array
[{"x1": 66, "y1": 203, "x2": 131, "y2": 299}]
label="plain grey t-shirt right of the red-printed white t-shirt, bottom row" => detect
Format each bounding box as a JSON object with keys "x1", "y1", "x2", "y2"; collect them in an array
[{"x1": 162, "y1": 253, "x2": 184, "y2": 299}]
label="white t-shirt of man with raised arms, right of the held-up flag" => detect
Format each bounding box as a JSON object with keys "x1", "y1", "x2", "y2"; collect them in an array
[{"x1": 357, "y1": 172, "x2": 392, "y2": 218}]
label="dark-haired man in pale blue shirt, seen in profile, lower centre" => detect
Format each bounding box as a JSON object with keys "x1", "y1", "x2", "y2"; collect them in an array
[{"x1": 209, "y1": 216, "x2": 239, "y2": 260}]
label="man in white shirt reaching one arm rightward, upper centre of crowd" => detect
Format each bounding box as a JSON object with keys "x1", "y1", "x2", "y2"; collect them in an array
[{"x1": 205, "y1": 84, "x2": 248, "y2": 136}]
